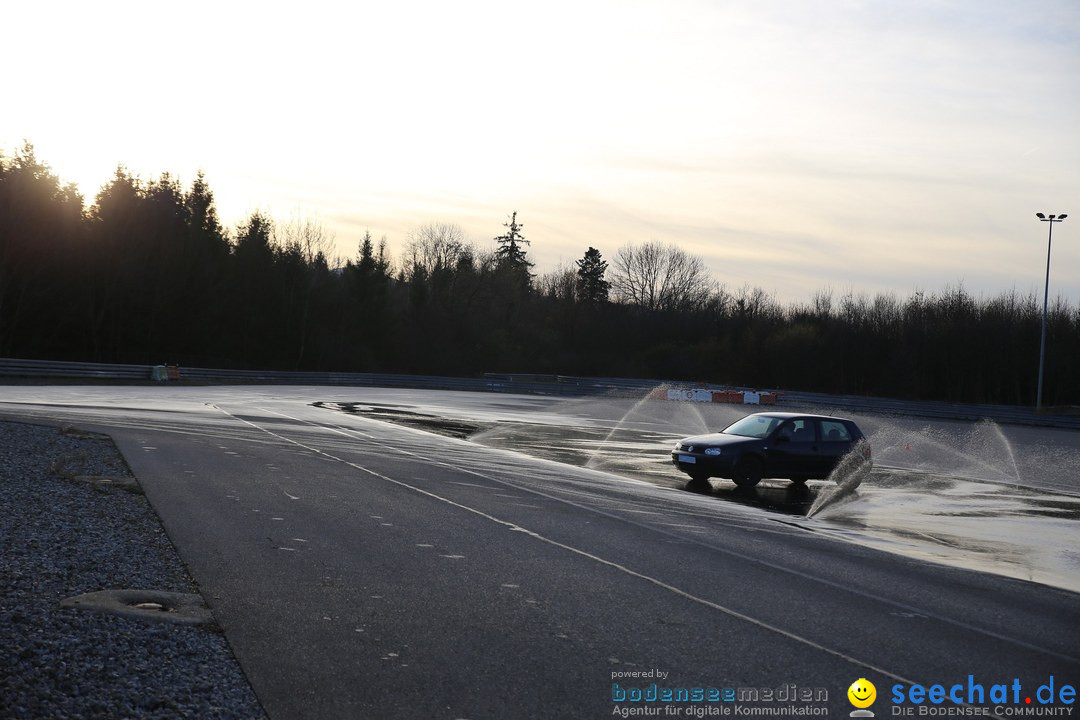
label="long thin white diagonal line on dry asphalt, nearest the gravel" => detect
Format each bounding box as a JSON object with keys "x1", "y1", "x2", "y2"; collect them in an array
[{"x1": 214, "y1": 408, "x2": 916, "y2": 685}]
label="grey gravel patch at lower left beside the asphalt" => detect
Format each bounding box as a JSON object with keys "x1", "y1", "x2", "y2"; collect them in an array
[{"x1": 0, "y1": 422, "x2": 266, "y2": 720}]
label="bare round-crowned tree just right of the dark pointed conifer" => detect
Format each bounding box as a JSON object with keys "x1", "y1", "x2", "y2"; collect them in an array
[{"x1": 611, "y1": 241, "x2": 715, "y2": 311}]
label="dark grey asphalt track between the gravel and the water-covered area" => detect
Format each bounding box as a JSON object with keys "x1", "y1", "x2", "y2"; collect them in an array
[{"x1": 0, "y1": 388, "x2": 1080, "y2": 720}]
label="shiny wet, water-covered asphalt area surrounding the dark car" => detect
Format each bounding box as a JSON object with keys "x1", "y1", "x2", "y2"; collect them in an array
[{"x1": 316, "y1": 400, "x2": 1080, "y2": 592}]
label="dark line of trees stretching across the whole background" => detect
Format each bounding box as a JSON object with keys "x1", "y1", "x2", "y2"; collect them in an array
[{"x1": 0, "y1": 145, "x2": 1080, "y2": 405}]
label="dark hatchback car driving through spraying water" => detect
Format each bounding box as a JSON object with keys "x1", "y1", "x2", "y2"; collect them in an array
[{"x1": 672, "y1": 412, "x2": 872, "y2": 487}]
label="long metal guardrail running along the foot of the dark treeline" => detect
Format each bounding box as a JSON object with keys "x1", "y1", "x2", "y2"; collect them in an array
[{"x1": 0, "y1": 358, "x2": 1080, "y2": 430}]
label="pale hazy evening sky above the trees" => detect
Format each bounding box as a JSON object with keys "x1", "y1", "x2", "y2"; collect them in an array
[{"x1": 0, "y1": 0, "x2": 1080, "y2": 303}]
